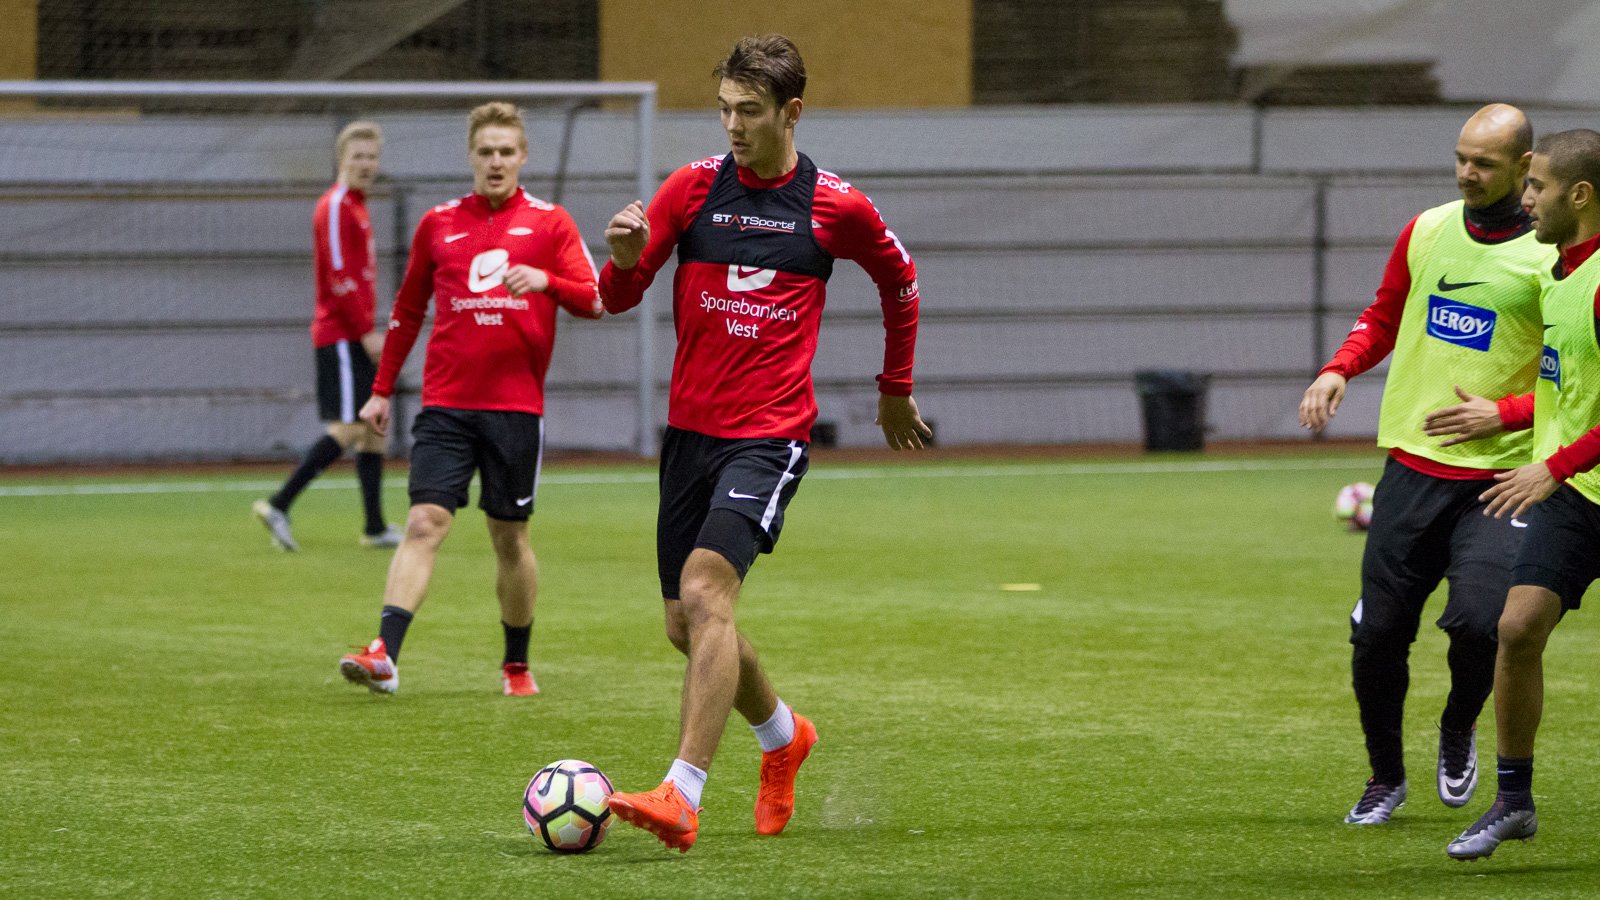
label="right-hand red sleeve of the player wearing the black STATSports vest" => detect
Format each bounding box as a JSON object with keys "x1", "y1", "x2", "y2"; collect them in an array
[{"x1": 826, "y1": 191, "x2": 922, "y2": 397}]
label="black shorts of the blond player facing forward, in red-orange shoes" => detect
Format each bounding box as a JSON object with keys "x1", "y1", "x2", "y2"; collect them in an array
[{"x1": 411, "y1": 407, "x2": 544, "y2": 522}]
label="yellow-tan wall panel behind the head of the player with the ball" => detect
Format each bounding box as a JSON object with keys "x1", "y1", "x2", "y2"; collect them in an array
[{"x1": 600, "y1": 0, "x2": 973, "y2": 109}]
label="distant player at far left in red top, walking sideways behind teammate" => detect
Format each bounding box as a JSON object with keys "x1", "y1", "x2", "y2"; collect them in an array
[{"x1": 253, "y1": 122, "x2": 400, "y2": 551}]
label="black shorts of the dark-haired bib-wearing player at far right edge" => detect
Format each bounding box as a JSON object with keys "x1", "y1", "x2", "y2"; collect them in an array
[{"x1": 1510, "y1": 484, "x2": 1600, "y2": 610}]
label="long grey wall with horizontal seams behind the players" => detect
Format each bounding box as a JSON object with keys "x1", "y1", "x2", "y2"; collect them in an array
[{"x1": 0, "y1": 107, "x2": 1529, "y2": 461}]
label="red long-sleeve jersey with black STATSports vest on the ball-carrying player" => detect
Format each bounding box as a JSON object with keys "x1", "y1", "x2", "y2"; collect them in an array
[{"x1": 600, "y1": 154, "x2": 920, "y2": 440}]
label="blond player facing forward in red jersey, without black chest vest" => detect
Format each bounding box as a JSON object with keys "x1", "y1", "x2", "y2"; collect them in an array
[{"x1": 339, "y1": 102, "x2": 602, "y2": 695}]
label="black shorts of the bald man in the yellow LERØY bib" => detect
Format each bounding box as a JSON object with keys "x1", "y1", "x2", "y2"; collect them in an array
[{"x1": 1350, "y1": 458, "x2": 1528, "y2": 642}]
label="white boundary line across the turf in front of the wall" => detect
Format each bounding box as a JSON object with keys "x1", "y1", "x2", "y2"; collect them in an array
[{"x1": 0, "y1": 456, "x2": 1382, "y2": 498}]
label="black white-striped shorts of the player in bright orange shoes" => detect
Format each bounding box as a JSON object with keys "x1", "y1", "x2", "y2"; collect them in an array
[{"x1": 656, "y1": 428, "x2": 811, "y2": 601}]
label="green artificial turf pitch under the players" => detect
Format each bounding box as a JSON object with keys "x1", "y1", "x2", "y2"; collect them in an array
[{"x1": 0, "y1": 452, "x2": 1600, "y2": 898}]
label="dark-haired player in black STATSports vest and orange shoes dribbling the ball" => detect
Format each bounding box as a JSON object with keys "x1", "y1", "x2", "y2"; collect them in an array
[{"x1": 600, "y1": 35, "x2": 933, "y2": 852}]
